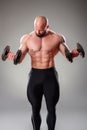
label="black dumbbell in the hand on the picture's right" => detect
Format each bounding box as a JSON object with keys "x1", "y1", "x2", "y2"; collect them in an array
[{"x1": 65, "y1": 43, "x2": 85, "y2": 62}]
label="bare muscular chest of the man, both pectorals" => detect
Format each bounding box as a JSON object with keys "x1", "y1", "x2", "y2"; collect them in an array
[{"x1": 27, "y1": 37, "x2": 59, "y2": 51}]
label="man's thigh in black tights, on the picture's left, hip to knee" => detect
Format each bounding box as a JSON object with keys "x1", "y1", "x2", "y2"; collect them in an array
[{"x1": 27, "y1": 71, "x2": 43, "y2": 107}]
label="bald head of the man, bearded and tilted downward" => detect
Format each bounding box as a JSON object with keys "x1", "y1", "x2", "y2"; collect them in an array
[{"x1": 34, "y1": 16, "x2": 49, "y2": 37}]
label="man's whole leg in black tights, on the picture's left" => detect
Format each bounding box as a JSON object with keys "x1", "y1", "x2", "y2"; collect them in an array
[{"x1": 27, "y1": 71, "x2": 43, "y2": 130}]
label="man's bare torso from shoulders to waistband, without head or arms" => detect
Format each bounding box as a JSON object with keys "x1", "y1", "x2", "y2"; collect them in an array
[{"x1": 27, "y1": 31, "x2": 60, "y2": 69}]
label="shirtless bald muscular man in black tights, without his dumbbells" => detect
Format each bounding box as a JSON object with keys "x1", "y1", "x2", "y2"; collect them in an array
[{"x1": 8, "y1": 16, "x2": 79, "y2": 130}]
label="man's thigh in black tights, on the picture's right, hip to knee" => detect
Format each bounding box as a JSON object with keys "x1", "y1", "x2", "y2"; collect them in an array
[{"x1": 44, "y1": 75, "x2": 60, "y2": 107}]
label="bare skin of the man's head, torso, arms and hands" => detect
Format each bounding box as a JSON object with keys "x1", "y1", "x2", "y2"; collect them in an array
[{"x1": 8, "y1": 16, "x2": 79, "y2": 69}]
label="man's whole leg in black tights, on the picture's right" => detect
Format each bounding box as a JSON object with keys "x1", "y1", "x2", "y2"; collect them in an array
[{"x1": 44, "y1": 70, "x2": 59, "y2": 130}]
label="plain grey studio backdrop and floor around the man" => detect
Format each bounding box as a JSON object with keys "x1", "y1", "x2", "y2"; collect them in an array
[{"x1": 0, "y1": 0, "x2": 87, "y2": 130}]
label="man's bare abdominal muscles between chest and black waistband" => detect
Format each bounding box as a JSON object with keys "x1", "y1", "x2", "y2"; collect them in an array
[{"x1": 29, "y1": 50, "x2": 54, "y2": 69}]
